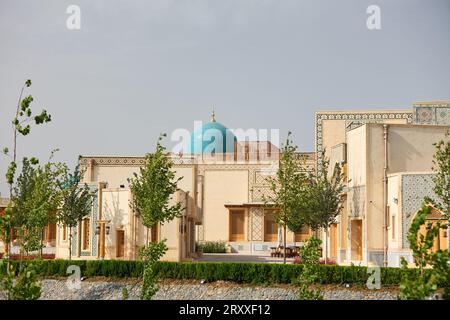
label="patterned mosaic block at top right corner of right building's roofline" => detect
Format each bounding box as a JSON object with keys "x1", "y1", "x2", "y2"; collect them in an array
[{"x1": 414, "y1": 102, "x2": 450, "y2": 126}]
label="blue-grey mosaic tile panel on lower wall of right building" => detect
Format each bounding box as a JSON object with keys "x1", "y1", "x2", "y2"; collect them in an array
[{"x1": 402, "y1": 174, "x2": 435, "y2": 248}]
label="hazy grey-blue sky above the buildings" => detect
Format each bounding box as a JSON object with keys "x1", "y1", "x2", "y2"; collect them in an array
[{"x1": 0, "y1": 0, "x2": 450, "y2": 196}]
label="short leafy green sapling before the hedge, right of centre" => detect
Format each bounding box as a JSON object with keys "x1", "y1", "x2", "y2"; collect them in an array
[{"x1": 296, "y1": 237, "x2": 323, "y2": 300}]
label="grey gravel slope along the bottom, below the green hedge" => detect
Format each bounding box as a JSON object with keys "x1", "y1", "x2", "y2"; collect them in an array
[{"x1": 37, "y1": 279, "x2": 397, "y2": 300}]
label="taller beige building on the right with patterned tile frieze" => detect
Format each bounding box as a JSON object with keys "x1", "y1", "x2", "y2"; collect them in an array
[{"x1": 322, "y1": 102, "x2": 450, "y2": 266}]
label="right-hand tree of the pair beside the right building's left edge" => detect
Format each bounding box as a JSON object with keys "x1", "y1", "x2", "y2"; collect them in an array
[{"x1": 304, "y1": 152, "x2": 344, "y2": 263}]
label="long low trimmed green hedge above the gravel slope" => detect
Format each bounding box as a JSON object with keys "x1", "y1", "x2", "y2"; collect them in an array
[{"x1": 10, "y1": 260, "x2": 426, "y2": 285}]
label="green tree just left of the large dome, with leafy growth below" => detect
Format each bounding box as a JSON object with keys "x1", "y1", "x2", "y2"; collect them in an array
[{"x1": 129, "y1": 135, "x2": 184, "y2": 300}]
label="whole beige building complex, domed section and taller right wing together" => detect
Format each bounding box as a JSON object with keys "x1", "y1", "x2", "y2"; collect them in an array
[{"x1": 51, "y1": 101, "x2": 450, "y2": 266}]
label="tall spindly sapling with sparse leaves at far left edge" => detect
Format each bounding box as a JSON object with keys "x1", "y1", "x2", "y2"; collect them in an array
[{"x1": 1, "y1": 79, "x2": 51, "y2": 256}]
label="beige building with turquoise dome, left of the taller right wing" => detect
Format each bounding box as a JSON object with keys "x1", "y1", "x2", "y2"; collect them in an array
[{"x1": 56, "y1": 115, "x2": 316, "y2": 261}]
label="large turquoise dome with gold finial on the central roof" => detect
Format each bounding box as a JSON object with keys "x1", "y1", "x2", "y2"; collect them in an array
[{"x1": 188, "y1": 116, "x2": 236, "y2": 154}]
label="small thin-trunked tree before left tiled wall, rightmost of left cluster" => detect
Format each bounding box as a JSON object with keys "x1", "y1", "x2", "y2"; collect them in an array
[{"x1": 56, "y1": 166, "x2": 94, "y2": 260}]
